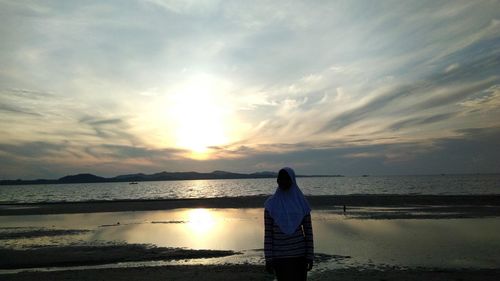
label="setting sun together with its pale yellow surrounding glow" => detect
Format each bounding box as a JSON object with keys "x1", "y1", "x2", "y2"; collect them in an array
[{"x1": 137, "y1": 73, "x2": 246, "y2": 160}]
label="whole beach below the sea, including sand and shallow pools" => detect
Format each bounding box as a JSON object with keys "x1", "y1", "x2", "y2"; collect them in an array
[{"x1": 0, "y1": 195, "x2": 500, "y2": 280}]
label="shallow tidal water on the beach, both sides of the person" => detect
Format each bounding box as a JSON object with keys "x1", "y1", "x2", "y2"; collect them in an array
[{"x1": 0, "y1": 209, "x2": 500, "y2": 268}]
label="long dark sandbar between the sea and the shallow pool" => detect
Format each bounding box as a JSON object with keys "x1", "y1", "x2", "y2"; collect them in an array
[{"x1": 0, "y1": 195, "x2": 500, "y2": 217}]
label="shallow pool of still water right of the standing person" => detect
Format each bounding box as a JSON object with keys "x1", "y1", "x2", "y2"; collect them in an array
[{"x1": 316, "y1": 215, "x2": 500, "y2": 268}]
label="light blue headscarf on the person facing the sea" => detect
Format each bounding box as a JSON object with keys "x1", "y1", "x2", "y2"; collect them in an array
[{"x1": 264, "y1": 167, "x2": 311, "y2": 234}]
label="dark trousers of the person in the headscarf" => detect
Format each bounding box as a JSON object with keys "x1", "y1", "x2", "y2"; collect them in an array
[{"x1": 273, "y1": 257, "x2": 307, "y2": 281}]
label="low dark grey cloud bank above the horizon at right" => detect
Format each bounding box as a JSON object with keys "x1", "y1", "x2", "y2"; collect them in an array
[{"x1": 247, "y1": 127, "x2": 500, "y2": 175}]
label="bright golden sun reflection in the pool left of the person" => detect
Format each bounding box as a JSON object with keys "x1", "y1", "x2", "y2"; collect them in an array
[{"x1": 103, "y1": 209, "x2": 263, "y2": 251}]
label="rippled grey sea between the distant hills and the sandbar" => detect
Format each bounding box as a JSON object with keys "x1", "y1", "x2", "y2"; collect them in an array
[{"x1": 0, "y1": 174, "x2": 500, "y2": 204}]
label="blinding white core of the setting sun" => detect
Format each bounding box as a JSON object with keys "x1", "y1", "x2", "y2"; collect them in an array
[{"x1": 170, "y1": 75, "x2": 229, "y2": 159}]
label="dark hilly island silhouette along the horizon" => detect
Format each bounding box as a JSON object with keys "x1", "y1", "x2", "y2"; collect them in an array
[{"x1": 0, "y1": 171, "x2": 342, "y2": 185}]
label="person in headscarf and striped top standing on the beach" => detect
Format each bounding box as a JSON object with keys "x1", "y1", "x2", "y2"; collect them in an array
[{"x1": 264, "y1": 167, "x2": 314, "y2": 281}]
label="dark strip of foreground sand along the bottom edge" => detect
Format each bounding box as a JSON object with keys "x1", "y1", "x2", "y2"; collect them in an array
[{"x1": 0, "y1": 265, "x2": 500, "y2": 281}]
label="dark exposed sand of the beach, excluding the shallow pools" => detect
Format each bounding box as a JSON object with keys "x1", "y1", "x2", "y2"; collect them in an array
[{"x1": 0, "y1": 195, "x2": 500, "y2": 281}]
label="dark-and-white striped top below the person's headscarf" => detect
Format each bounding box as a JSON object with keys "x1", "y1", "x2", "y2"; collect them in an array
[{"x1": 264, "y1": 210, "x2": 314, "y2": 262}]
